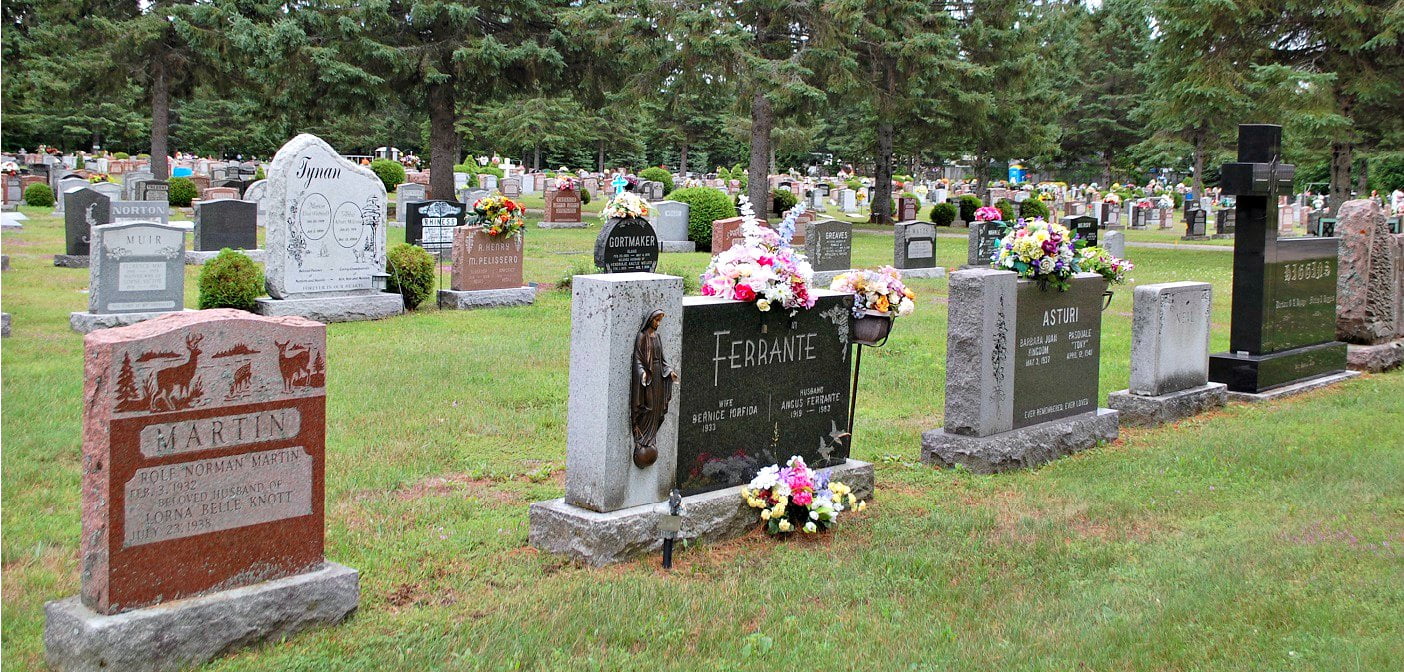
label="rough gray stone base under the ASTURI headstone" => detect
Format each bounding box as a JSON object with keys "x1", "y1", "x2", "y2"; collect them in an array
[{"x1": 921, "y1": 408, "x2": 1119, "y2": 474}]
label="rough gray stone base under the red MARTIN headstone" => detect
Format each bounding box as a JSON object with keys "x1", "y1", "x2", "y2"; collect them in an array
[{"x1": 44, "y1": 563, "x2": 361, "y2": 672}]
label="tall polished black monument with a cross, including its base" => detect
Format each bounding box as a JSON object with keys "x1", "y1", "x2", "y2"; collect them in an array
[{"x1": 1209, "y1": 123, "x2": 1345, "y2": 393}]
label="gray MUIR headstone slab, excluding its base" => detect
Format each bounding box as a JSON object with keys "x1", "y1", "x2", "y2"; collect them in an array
[{"x1": 88, "y1": 222, "x2": 185, "y2": 313}]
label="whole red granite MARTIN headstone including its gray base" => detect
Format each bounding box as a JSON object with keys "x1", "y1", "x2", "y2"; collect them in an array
[{"x1": 44, "y1": 310, "x2": 359, "y2": 671}]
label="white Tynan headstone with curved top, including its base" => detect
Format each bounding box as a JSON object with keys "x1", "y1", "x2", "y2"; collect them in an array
[{"x1": 258, "y1": 133, "x2": 404, "y2": 321}]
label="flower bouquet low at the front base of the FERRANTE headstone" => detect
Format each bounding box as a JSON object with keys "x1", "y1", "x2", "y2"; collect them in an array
[{"x1": 741, "y1": 456, "x2": 868, "y2": 535}]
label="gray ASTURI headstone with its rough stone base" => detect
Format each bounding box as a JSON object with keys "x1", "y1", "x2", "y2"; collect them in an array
[{"x1": 921, "y1": 268, "x2": 1118, "y2": 473}]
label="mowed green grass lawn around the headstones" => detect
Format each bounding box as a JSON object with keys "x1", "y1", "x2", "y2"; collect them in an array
[{"x1": 0, "y1": 202, "x2": 1404, "y2": 671}]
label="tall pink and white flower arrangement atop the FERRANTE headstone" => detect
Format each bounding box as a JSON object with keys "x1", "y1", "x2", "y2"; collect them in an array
[{"x1": 702, "y1": 196, "x2": 816, "y2": 314}]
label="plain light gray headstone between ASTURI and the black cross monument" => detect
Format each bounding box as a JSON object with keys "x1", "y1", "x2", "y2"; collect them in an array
[{"x1": 1108, "y1": 283, "x2": 1229, "y2": 426}]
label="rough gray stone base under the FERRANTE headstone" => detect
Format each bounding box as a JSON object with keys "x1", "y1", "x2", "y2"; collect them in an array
[{"x1": 528, "y1": 460, "x2": 873, "y2": 567}]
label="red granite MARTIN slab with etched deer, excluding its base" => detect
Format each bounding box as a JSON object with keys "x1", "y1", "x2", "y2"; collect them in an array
[{"x1": 81, "y1": 309, "x2": 327, "y2": 614}]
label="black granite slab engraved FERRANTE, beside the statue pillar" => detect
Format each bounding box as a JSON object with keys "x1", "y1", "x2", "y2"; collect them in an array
[{"x1": 677, "y1": 295, "x2": 852, "y2": 494}]
